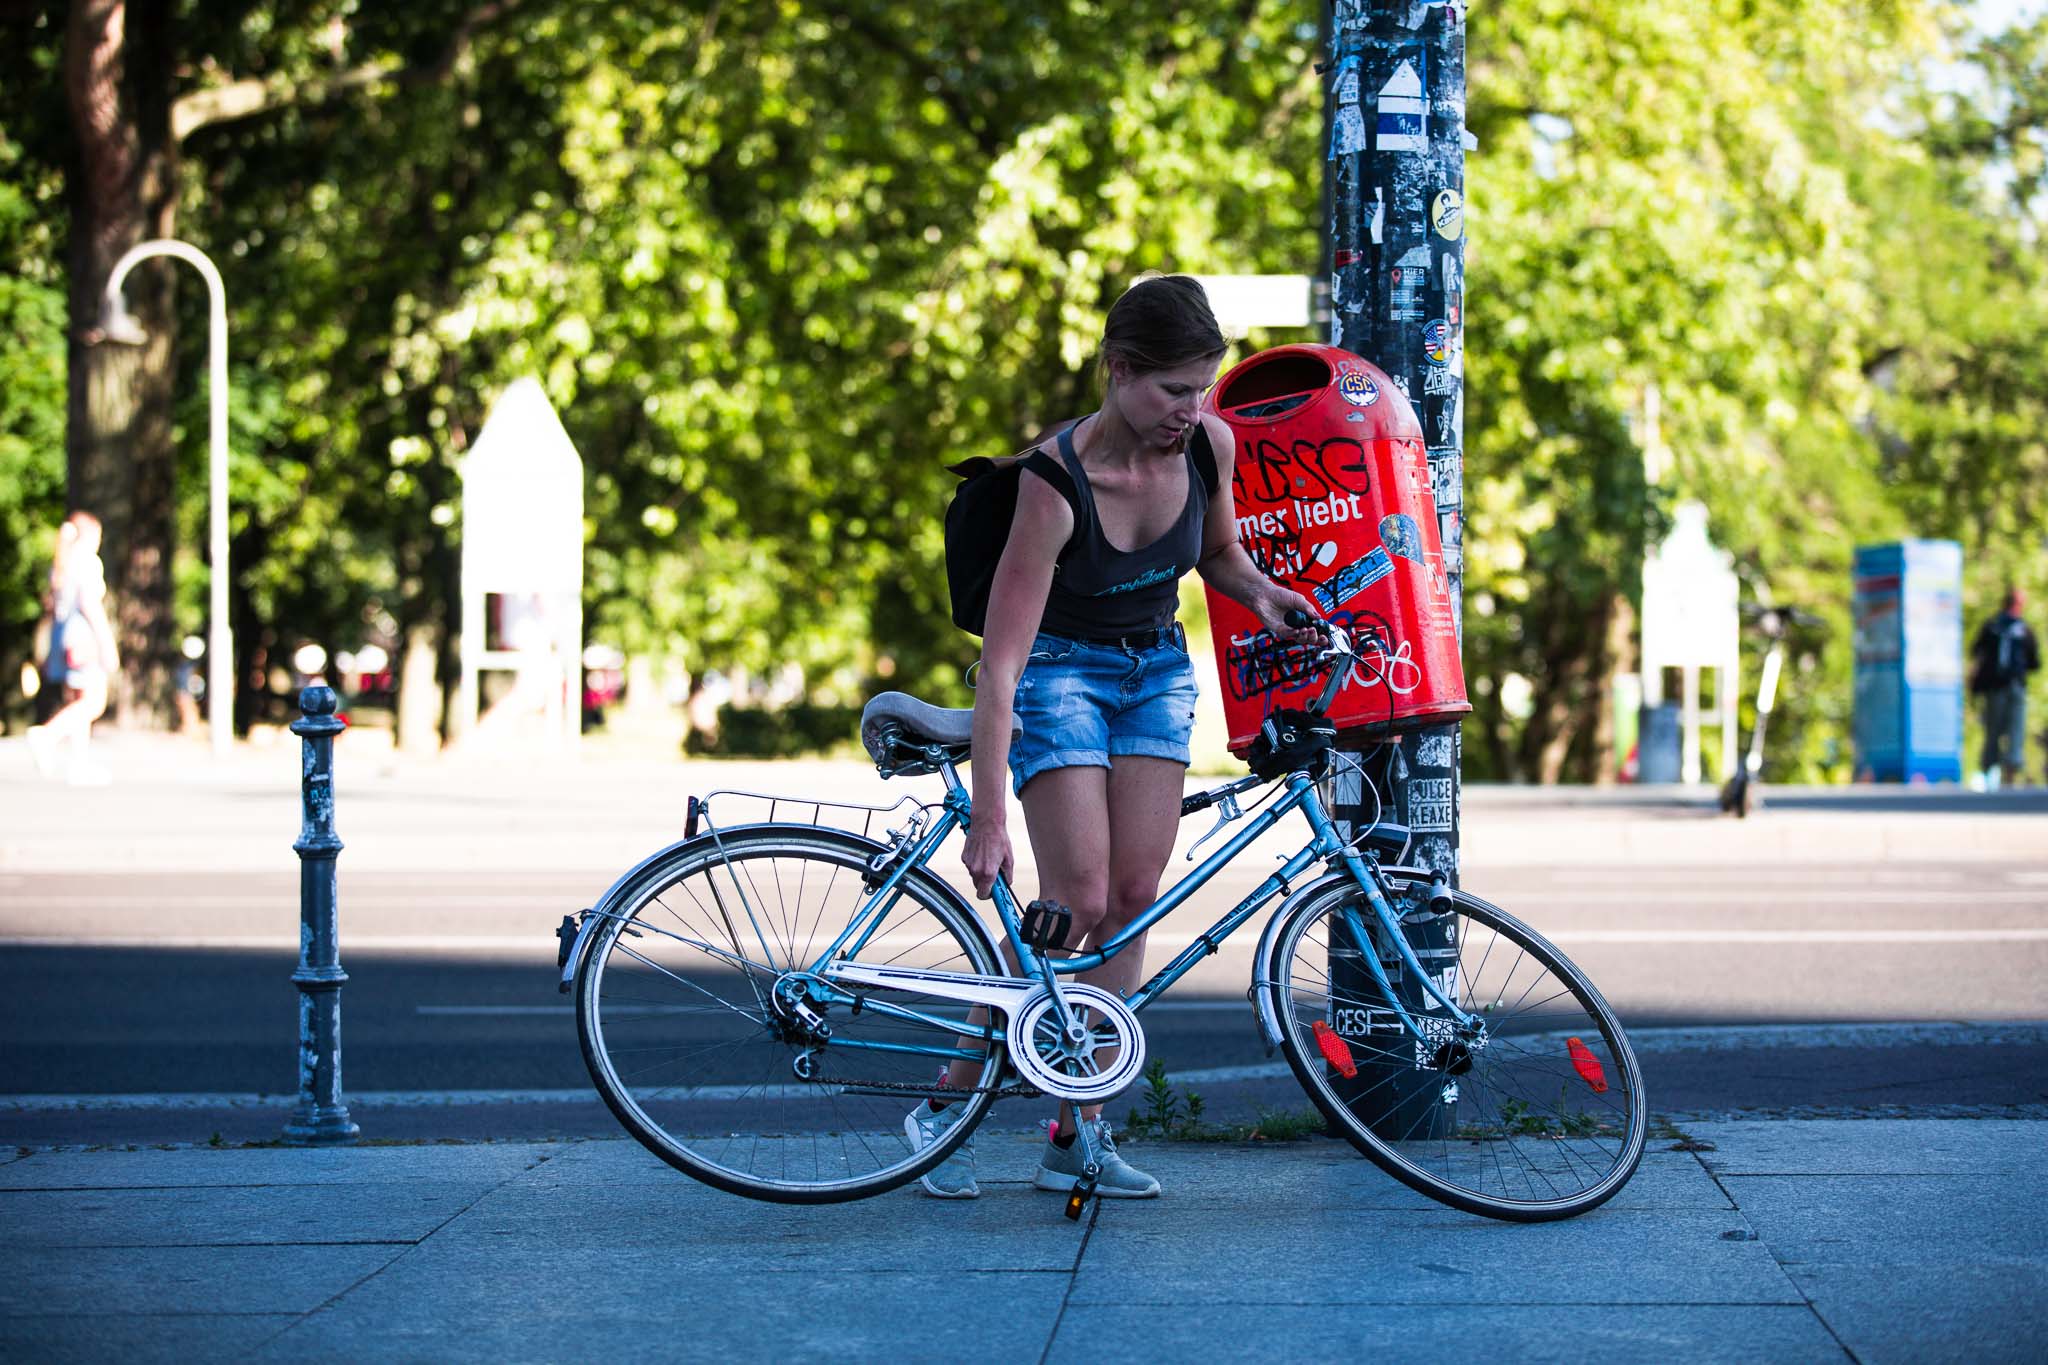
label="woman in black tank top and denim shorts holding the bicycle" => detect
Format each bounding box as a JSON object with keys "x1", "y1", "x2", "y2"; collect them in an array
[{"x1": 903, "y1": 276, "x2": 1315, "y2": 1199}]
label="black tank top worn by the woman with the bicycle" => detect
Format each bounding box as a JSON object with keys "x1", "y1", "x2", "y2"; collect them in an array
[{"x1": 1026, "y1": 422, "x2": 1217, "y2": 641}]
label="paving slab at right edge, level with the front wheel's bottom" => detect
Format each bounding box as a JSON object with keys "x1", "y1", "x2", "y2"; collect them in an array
[{"x1": 1720, "y1": 1173, "x2": 2048, "y2": 1265}]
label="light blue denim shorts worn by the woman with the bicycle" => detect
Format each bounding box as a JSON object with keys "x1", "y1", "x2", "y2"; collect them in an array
[{"x1": 1010, "y1": 634, "x2": 1194, "y2": 792}]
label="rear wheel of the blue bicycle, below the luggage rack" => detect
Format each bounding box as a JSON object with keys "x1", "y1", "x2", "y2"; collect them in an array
[{"x1": 575, "y1": 825, "x2": 1004, "y2": 1203}]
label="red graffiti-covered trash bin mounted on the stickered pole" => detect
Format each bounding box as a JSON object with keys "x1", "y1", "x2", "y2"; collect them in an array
[{"x1": 1206, "y1": 346, "x2": 1473, "y2": 751}]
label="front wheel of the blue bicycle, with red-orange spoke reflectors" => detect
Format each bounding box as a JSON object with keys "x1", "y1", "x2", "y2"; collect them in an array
[{"x1": 1266, "y1": 874, "x2": 1645, "y2": 1222}]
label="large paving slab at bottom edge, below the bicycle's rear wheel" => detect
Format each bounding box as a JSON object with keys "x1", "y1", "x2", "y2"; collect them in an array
[{"x1": 254, "y1": 1260, "x2": 1067, "y2": 1365}]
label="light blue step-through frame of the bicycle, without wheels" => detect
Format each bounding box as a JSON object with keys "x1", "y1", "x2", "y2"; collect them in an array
[{"x1": 805, "y1": 761, "x2": 1477, "y2": 1062}]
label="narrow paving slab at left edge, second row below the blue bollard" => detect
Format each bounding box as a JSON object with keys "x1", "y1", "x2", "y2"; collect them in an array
[{"x1": 0, "y1": 1181, "x2": 500, "y2": 1248}]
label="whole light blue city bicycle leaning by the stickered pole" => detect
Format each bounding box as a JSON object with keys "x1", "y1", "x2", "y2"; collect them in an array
[{"x1": 559, "y1": 618, "x2": 1647, "y2": 1222}]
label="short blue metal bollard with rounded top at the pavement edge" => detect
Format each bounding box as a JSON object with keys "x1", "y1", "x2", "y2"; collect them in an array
[{"x1": 285, "y1": 688, "x2": 362, "y2": 1146}]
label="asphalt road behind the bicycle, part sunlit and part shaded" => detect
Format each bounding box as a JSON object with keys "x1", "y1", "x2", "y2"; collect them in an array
[{"x1": 0, "y1": 853, "x2": 2048, "y2": 1146}]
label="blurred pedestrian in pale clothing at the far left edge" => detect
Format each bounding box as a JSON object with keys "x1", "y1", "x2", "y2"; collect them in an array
[{"x1": 29, "y1": 512, "x2": 121, "y2": 786}]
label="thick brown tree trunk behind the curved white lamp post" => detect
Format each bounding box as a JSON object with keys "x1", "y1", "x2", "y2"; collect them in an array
[{"x1": 63, "y1": 0, "x2": 176, "y2": 729}]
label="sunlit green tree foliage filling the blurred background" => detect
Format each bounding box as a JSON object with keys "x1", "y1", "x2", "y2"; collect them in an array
[{"x1": 0, "y1": 0, "x2": 2048, "y2": 778}]
